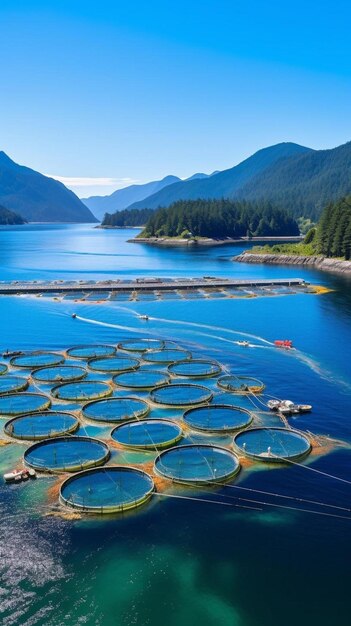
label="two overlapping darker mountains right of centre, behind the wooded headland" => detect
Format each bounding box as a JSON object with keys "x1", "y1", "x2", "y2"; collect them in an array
[{"x1": 97, "y1": 142, "x2": 351, "y2": 220}]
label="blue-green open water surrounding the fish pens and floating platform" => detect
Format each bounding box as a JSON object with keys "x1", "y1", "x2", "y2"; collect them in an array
[{"x1": 0, "y1": 225, "x2": 351, "y2": 626}]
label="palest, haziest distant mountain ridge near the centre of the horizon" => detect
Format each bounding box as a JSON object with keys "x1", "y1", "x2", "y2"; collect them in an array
[{"x1": 82, "y1": 173, "x2": 212, "y2": 219}]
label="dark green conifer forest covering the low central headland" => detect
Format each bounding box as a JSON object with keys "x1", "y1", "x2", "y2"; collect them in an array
[{"x1": 141, "y1": 199, "x2": 299, "y2": 238}]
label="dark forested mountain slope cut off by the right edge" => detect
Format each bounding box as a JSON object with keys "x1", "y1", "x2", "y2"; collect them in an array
[{"x1": 237, "y1": 142, "x2": 351, "y2": 220}]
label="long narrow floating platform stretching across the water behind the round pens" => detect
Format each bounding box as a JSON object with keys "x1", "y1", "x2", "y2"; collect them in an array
[{"x1": 0, "y1": 276, "x2": 309, "y2": 295}]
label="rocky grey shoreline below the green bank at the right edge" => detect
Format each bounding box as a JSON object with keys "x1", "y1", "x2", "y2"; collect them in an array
[{"x1": 232, "y1": 252, "x2": 351, "y2": 274}]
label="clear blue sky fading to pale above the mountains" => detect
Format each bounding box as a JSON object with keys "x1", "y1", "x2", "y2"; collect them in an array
[{"x1": 0, "y1": 0, "x2": 351, "y2": 195}]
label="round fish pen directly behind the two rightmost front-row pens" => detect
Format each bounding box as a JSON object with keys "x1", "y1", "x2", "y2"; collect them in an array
[{"x1": 183, "y1": 404, "x2": 252, "y2": 433}]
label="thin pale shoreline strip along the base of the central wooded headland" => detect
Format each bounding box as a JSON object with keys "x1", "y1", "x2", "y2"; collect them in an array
[{"x1": 127, "y1": 237, "x2": 302, "y2": 247}]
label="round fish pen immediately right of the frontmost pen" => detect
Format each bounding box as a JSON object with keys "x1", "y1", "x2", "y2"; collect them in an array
[{"x1": 154, "y1": 444, "x2": 240, "y2": 484}]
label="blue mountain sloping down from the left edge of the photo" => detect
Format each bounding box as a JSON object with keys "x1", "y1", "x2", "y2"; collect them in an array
[{"x1": 0, "y1": 152, "x2": 97, "y2": 223}]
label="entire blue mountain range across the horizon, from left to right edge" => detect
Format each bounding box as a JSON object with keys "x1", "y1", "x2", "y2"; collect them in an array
[{"x1": 4, "y1": 142, "x2": 351, "y2": 224}]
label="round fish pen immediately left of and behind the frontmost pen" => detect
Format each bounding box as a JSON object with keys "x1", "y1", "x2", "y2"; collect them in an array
[{"x1": 23, "y1": 435, "x2": 110, "y2": 473}]
